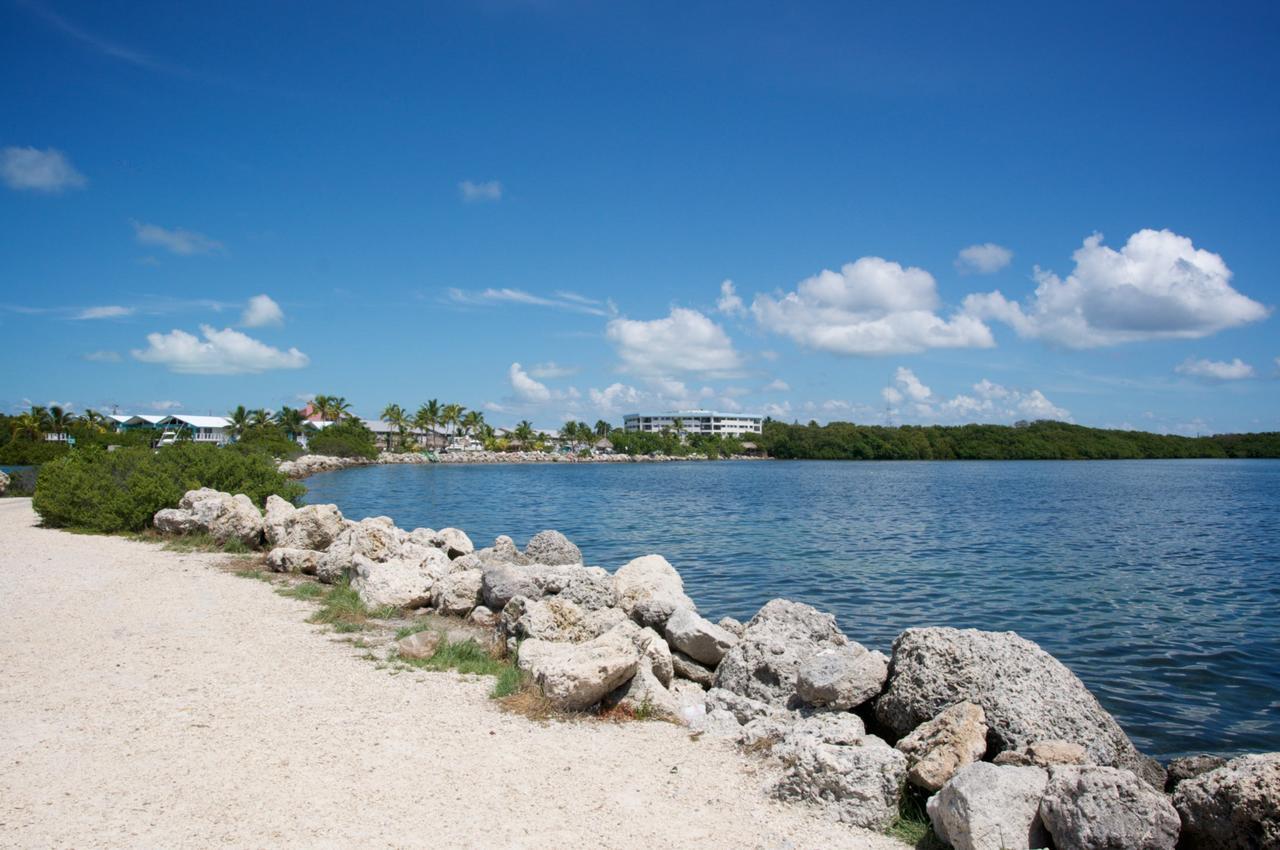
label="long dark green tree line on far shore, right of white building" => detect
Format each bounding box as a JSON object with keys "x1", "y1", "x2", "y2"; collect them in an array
[{"x1": 762, "y1": 420, "x2": 1280, "y2": 461}]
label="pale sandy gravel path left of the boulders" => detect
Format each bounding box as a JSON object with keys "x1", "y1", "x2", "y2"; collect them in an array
[{"x1": 0, "y1": 499, "x2": 904, "y2": 850}]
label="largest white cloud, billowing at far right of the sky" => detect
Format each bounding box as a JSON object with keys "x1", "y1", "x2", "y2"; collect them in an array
[{"x1": 965, "y1": 230, "x2": 1270, "y2": 348}]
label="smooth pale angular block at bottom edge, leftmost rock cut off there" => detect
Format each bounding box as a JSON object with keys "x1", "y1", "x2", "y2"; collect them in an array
[{"x1": 925, "y1": 762, "x2": 1048, "y2": 850}]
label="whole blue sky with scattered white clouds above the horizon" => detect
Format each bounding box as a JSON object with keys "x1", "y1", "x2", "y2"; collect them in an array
[{"x1": 0, "y1": 0, "x2": 1280, "y2": 434}]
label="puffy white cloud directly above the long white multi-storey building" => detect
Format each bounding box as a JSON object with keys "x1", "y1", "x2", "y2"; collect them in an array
[{"x1": 604, "y1": 307, "x2": 741, "y2": 376}]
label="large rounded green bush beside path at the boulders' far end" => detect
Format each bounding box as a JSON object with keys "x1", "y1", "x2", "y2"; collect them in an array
[{"x1": 32, "y1": 443, "x2": 306, "y2": 533}]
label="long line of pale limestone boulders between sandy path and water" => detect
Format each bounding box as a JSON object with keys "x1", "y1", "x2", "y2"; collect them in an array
[{"x1": 147, "y1": 490, "x2": 1280, "y2": 850}]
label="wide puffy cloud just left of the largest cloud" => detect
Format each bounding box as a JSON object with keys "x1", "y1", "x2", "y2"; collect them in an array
[{"x1": 751, "y1": 257, "x2": 995, "y2": 355}]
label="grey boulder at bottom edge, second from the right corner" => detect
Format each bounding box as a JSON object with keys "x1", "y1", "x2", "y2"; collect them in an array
[{"x1": 1039, "y1": 766, "x2": 1181, "y2": 850}]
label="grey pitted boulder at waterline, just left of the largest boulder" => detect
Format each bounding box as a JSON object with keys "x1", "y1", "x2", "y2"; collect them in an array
[{"x1": 711, "y1": 599, "x2": 849, "y2": 719}]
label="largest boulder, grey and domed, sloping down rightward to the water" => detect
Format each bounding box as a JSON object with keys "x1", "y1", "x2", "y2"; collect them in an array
[{"x1": 876, "y1": 627, "x2": 1165, "y2": 789}]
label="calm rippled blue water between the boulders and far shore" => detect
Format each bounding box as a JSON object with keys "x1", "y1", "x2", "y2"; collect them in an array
[{"x1": 307, "y1": 461, "x2": 1280, "y2": 758}]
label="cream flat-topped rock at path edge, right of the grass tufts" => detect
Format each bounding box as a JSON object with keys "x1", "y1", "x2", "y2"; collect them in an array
[{"x1": 517, "y1": 631, "x2": 640, "y2": 710}]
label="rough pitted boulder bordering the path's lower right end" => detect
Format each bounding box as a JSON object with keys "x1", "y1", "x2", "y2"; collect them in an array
[{"x1": 768, "y1": 732, "x2": 906, "y2": 830}]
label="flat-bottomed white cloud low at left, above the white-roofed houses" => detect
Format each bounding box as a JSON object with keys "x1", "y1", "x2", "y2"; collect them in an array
[{"x1": 132, "y1": 325, "x2": 310, "y2": 375}]
